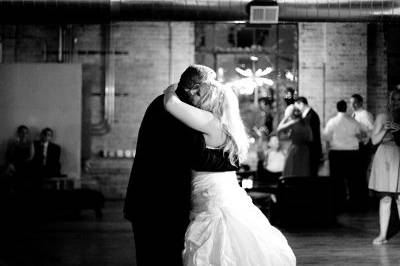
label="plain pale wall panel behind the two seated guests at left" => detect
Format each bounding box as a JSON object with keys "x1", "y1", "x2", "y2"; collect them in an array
[{"x1": 0, "y1": 64, "x2": 82, "y2": 178}]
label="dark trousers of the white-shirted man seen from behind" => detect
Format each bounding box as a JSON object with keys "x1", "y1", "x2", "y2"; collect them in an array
[{"x1": 329, "y1": 150, "x2": 367, "y2": 211}]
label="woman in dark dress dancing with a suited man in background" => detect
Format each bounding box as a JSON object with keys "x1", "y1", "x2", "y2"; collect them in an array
[{"x1": 277, "y1": 108, "x2": 312, "y2": 177}]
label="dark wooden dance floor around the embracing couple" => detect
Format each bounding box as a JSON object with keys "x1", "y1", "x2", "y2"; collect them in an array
[{"x1": 0, "y1": 202, "x2": 400, "y2": 266}]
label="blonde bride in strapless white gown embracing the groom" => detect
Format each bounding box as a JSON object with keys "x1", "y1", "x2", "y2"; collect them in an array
[{"x1": 164, "y1": 80, "x2": 296, "y2": 266}]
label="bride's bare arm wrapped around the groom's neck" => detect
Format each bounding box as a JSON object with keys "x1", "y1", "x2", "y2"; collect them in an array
[{"x1": 164, "y1": 85, "x2": 217, "y2": 135}]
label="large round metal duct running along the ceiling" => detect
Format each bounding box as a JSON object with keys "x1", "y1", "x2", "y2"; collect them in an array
[{"x1": 0, "y1": 0, "x2": 400, "y2": 23}]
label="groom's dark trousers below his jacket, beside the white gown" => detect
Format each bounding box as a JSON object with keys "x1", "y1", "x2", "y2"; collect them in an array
[{"x1": 132, "y1": 220, "x2": 184, "y2": 266}]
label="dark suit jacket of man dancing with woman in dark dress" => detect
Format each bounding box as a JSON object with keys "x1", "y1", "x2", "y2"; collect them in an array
[{"x1": 304, "y1": 108, "x2": 322, "y2": 161}]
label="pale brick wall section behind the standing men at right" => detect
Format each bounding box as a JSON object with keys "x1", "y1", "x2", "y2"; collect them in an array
[{"x1": 299, "y1": 23, "x2": 367, "y2": 125}]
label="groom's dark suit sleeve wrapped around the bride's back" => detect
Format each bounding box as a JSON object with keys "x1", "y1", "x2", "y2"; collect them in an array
[{"x1": 191, "y1": 132, "x2": 238, "y2": 172}]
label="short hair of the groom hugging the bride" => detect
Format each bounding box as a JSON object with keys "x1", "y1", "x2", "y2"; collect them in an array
[{"x1": 176, "y1": 65, "x2": 216, "y2": 96}]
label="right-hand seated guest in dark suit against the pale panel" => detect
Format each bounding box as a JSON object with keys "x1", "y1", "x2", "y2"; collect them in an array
[{"x1": 33, "y1": 128, "x2": 61, "y2": 178}]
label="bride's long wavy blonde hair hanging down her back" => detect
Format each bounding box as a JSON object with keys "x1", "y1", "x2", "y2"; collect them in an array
[{"x1": 196, "y1": 80, "x2": 249, "y2": 165}]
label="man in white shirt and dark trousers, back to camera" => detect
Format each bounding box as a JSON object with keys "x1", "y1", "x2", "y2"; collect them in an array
[{"x1": 323, "y1": 100, "x2": 365, "y2": 211}]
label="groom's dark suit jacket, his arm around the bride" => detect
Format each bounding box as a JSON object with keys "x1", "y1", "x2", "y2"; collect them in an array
[{"x1": 124, "y1": 95, "x2": 236, "y2": 229}]
